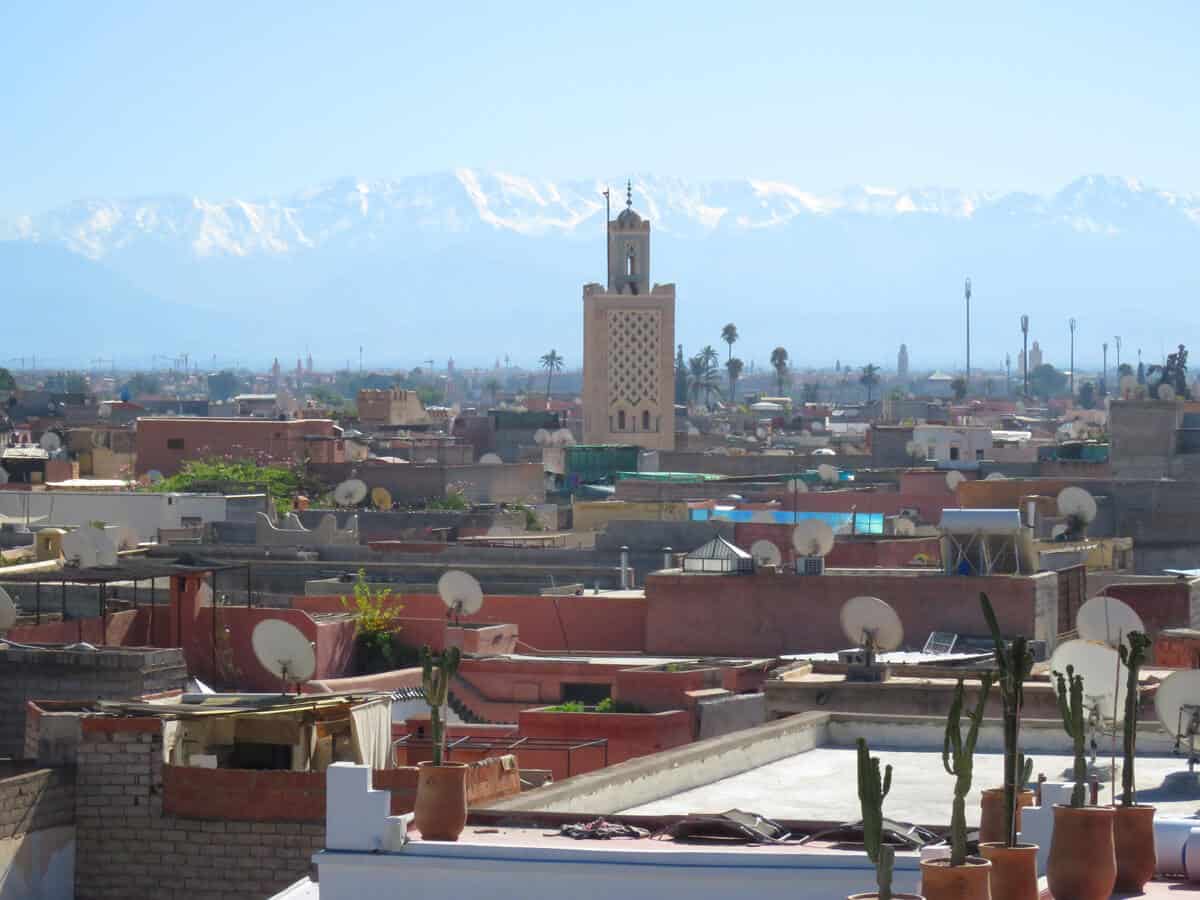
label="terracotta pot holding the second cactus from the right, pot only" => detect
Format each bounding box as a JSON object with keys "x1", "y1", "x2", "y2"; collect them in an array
[{"x1": 1046, "y1": 804, "x2": 1117, "y2": 900}]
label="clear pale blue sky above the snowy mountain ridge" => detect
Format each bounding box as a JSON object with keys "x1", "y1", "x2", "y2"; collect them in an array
[{"x1": 0, "y1": 0, "x2": 1200, "y2": 216}]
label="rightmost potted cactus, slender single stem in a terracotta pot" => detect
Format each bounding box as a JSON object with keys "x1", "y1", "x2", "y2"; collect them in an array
[{"x1": 1112, "y1": 631, "x2": 1158, "y2": 894}]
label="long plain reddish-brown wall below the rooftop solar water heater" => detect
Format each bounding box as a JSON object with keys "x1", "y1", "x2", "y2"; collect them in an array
[{"x1": 646, "y1": 574, "x2": 1036, "y2": 656}]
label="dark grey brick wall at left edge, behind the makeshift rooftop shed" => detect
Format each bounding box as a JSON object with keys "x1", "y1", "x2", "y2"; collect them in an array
[{"x1": 0, "y1": 647, "x2": 187, "y2": 757}]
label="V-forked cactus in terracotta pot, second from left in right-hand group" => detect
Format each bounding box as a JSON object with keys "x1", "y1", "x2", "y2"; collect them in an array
[{"x1": 920, "y1": 672, "x2": 991, "y2": 900}]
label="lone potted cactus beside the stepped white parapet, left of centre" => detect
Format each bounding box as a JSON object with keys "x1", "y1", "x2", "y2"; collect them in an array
[{"x1": 414, "y1": 646, "x2": 467, "y2": 841}]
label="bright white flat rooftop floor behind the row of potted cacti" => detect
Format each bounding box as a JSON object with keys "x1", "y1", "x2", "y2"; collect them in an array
[{"x1": 622, "y1": 746, "x2": 1200, "y2": 826}]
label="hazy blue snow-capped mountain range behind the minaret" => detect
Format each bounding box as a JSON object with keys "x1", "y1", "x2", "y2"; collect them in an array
[{"x1": 0, "y1": 169, "x2": 1200, "y2": 368}]
